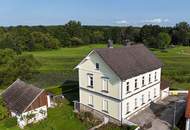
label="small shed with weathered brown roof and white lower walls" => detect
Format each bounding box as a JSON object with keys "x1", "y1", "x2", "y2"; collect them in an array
[{"x1": 2, "y1": 79, "x2": 50, "y2": 128}]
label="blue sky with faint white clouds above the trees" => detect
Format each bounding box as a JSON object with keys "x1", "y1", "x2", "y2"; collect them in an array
[{"x1": 0, "y1": 0, "x2": 190, "y2": 26}]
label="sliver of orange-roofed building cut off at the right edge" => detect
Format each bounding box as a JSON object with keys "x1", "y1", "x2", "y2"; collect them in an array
[{"x1": 185, "y1": 90, "x2": 190, "y2": 130}]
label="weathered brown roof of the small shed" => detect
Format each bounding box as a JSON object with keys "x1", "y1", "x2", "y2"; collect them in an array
[{"x1": 2, "y1": 79, "x2": 44, "y2": 113}]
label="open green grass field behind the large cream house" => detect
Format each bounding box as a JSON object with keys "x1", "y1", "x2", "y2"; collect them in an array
[{"x1": 25, "y1": 44, "x2": 190, "y2": 89}]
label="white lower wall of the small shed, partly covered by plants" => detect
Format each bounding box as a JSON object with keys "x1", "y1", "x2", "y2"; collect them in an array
[{"x1": 11, "y1": 106, "x2": 47, "y2": 128}]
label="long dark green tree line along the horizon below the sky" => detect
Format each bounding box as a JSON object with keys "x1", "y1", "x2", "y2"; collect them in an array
[{"x1": 0, "y1": 21, "x2": 190, "y2": 53}]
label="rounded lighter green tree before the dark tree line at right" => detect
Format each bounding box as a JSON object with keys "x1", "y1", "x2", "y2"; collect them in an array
[{"x1": 157, "y1": 32, "x2": 171, "y2": 49}]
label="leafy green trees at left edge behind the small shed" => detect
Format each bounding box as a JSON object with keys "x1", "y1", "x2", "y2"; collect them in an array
[{"x1": 0, "y1": 49, "x2": 40, "y2": 86}]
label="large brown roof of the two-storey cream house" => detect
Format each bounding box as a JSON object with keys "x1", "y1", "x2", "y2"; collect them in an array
[{"x1": 94, "y1": 44, "x2": 162, "y2": 80}]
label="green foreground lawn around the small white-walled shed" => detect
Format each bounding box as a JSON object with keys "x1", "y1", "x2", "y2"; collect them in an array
[{"x1": 0, "y1": 100, "x2": 88, "y2": 130}]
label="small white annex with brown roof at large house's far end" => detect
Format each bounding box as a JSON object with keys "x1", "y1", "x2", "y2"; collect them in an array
[{"x1": 160, "y1": 80, "x2": 169, "y2": 99}]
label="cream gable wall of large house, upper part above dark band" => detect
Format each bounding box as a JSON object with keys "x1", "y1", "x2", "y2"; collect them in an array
[{"x1": 79, "y1": 52, "x2": 121, "y2": 99}]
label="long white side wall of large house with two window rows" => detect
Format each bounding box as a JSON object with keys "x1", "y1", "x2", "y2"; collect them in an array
[{"x1": 122, "y1": 69, "x2": 161, "y2": 119}]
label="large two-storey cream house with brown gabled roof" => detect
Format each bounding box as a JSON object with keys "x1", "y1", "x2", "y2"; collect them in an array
[{"x1": 76, "y1": 44, "x2": 162, "y2": 123}]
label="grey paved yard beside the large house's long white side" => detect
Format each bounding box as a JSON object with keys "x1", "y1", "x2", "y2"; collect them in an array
[{"x1": 129, "y1": 95, "x2": 186, "y2": 130}]
